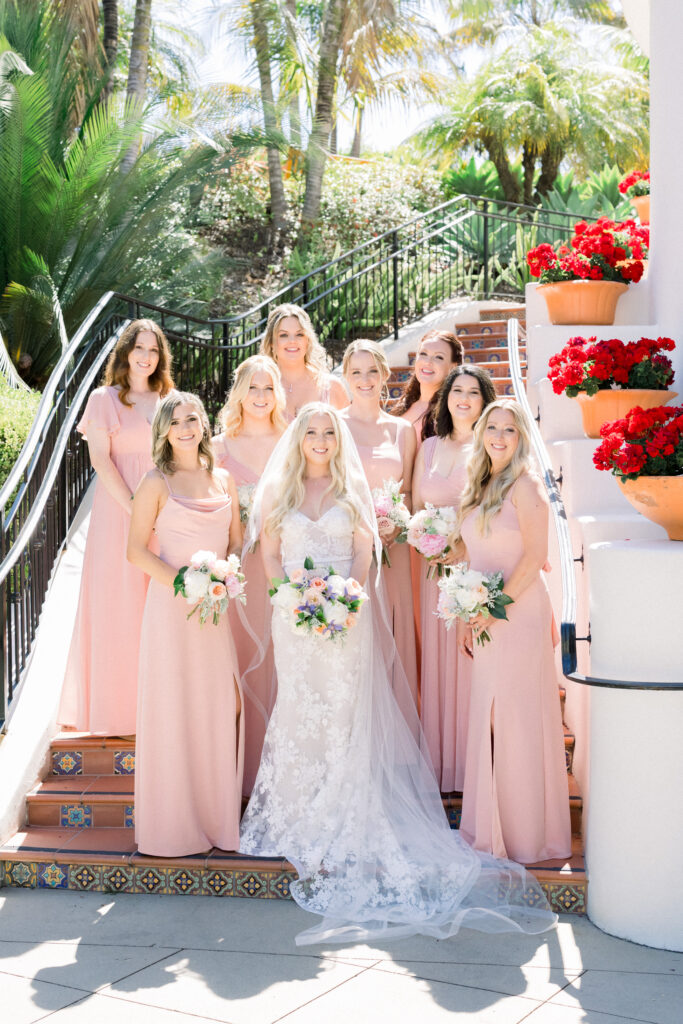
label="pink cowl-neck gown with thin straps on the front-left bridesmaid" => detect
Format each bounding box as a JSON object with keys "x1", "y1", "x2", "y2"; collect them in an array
[{"x1": 135, "y1": 481, "x2": 244, "y2": 857}]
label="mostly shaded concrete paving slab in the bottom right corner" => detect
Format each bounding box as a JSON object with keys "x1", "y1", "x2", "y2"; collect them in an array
[{"x1": 552, "y1": 971, "x2": 683, "y2": 1024}]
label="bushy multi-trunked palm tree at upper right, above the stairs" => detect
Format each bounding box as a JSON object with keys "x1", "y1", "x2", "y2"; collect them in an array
[{"x1": 423, "y1": 24, "x2": 648, "y2": 204}]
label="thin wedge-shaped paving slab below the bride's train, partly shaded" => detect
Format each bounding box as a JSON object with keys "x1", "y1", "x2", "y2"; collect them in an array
[{"x1": 373, "y1": 959, "x2": 578, "y2": 1000}]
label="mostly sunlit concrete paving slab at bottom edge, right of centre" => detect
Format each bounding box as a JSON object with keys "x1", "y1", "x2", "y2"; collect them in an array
[{"x1": 278, "y1": 970, "x2": 539, "y2": 1024}]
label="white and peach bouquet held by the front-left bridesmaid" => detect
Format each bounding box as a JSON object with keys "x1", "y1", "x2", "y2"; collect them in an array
[{"x1": 173, "y1": 551, "x2": 247, "y2": 626}]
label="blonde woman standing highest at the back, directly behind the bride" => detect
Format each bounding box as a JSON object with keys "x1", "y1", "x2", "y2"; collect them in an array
[{"x1": 260, "y1": 302, "x2": 348, "y2": 421}]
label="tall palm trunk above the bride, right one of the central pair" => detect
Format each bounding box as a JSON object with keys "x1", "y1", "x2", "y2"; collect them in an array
[{"x1": 300, "y1": 0, "x2": 349, "y2": 238}]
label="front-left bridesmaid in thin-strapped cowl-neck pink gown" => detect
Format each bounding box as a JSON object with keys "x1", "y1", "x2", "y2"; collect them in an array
[{"x1": 128, "y1": 392, "x2": 244, "y2": 857}]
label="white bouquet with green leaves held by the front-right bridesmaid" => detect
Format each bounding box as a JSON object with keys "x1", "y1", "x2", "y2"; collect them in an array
[{"x1": 436, "y1": 562, "x2": 513, "y2": 644}]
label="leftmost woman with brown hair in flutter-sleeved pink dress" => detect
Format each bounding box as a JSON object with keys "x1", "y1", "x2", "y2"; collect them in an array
[{"x1": 57, "y1": 319, "x2": 173, "y2": 736}]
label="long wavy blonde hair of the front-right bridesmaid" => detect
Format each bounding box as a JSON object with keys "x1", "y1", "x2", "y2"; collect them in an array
[{"x1": 456, "y1": 398, "x2": 531, "y2": 539}]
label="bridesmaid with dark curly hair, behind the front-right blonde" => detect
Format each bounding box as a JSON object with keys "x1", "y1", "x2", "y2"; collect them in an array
[{"x1": 413, "y1": 362, "x2": 496, "y2": 793}]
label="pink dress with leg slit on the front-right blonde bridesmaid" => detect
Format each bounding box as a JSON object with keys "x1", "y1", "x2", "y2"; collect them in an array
[{"x1": 460, "y1": 487, "x2": 571, "y2": 864}]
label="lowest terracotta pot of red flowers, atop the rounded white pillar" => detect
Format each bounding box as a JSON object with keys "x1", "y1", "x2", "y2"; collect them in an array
[{"x1": 593, "y1": 406, "x2": 683, "y2": 541}]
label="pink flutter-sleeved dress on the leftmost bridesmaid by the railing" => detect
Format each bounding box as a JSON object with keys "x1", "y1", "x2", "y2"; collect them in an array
[{"x1": 57, "y1": 386, "x2": 158, "y2": 736}]
